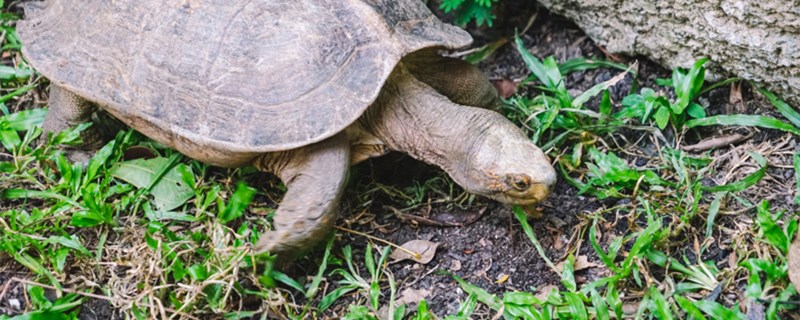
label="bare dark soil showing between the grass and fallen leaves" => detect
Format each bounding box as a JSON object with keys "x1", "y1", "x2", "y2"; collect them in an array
[{"x1": 0, "y1": 1, "x2": 797, "y2": 319}]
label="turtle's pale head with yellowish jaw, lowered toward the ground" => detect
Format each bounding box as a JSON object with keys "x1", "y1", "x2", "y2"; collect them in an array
[{"x1": 461, "y1": 114, "x2": 556, "y2": 205}]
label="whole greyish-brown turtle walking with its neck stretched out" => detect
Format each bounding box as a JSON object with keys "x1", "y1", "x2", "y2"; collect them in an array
[{"x1": 17, "y1": 0, "x2": 556, "y2": 255}]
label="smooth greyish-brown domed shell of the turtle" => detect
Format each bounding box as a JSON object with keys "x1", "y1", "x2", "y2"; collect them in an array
[{"x1": 17, "y1": 0, "x2": 472, "y2": 153}]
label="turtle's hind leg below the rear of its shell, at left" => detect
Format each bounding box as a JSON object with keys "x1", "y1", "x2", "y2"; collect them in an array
[{"x1": 42, "y1": 85, "x2": 107, "y2": 163}]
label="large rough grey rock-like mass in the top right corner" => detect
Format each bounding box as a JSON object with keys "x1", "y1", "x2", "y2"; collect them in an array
[{"x1": 539, "y1": 0, "x2": 800, "y2": 107}]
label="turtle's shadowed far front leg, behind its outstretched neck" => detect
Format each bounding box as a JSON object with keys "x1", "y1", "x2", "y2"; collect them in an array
[{"x1": 403, "y1": 50, "x2": 502, "y2": 111}]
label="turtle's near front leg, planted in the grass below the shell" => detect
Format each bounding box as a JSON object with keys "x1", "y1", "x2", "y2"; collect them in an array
[{"x1": 254, "y1": 132, "x2": 350, "y2": 259}]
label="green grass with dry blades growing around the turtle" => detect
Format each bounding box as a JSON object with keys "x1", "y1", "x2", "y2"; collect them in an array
[{"x1": 0, "y1": 6, "x2": 800, "y2": 319}]
